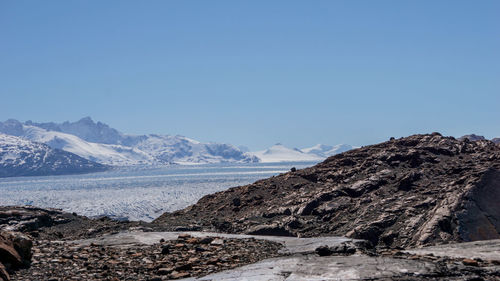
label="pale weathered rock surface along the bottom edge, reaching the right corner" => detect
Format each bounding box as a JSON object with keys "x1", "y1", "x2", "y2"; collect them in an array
[{"x1": 183, "y1": 255, "x2": 500, "y2": 281}]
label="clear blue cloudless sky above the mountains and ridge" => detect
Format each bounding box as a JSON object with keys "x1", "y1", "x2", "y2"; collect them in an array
[{"x1": 0, "y1": 0, "x2": 500, "y2": 149}]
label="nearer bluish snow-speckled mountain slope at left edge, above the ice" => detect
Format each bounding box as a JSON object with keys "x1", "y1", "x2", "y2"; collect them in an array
[{"x1": 0, "y1": 134, "x2": 107, "y2": 177}]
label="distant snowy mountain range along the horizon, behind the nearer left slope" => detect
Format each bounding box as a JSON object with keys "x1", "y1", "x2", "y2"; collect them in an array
[{"x1": 0, "y1": 117, "x2": 353, "y2": 166}]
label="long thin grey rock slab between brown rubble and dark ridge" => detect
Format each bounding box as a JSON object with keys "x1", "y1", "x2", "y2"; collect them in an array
[{"x1": 75, "y1": 231, "x2": 361, "y2": 254}]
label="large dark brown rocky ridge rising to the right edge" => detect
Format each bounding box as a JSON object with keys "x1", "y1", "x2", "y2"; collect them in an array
[{"x1": 155, "y1": 133, "x2": 500, "y2": 247}]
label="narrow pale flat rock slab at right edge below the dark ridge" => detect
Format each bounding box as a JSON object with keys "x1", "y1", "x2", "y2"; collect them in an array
[{"x1": 404, "y1": 239, "x2": 500, "y2": 261}]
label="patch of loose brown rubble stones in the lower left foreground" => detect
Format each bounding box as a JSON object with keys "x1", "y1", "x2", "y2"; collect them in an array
[{"x1": 8, "y1": 235, "x2": 282, "y2": 281}]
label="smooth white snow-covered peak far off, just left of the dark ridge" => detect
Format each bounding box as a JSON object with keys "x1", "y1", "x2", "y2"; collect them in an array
[{"x1": 251, "y1": 143, "x2": 323, "y2": 163}]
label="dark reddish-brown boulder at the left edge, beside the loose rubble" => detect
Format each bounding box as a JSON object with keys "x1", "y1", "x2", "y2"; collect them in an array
[{"x1": 0, "y1": 231, "x2": 32, "y2": 281}]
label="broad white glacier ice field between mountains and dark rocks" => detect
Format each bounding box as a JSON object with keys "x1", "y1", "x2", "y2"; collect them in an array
[{"x1": 0, "y1": 163, "x2": 312, "y2": 221}]
